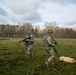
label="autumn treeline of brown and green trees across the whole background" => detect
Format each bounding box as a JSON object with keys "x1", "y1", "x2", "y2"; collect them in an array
[{"x1": 0, "y1": 22, "x2": 76, "y2": 38}]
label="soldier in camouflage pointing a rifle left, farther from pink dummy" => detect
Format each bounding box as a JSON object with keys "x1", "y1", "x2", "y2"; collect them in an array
[{"x1": 20, "y1": 32, "x2": 34, "y2": 58}]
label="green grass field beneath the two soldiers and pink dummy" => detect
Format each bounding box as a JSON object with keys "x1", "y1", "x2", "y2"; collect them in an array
[{"x1": 0, "y1": 38, "x2": 76, "y2": 75}]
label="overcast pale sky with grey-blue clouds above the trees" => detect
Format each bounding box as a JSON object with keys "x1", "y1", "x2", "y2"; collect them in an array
[{"x1": 0, "y1": 0, "x2": 76, "y2": 28}]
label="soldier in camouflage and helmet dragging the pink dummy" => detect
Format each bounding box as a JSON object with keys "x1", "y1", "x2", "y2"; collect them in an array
[{"x1": 43, "y1": 30, "x2": 57, "y2": 66}]
